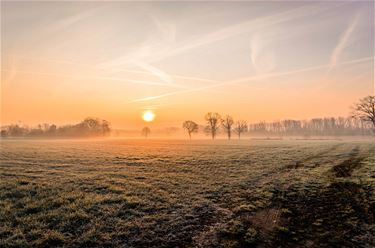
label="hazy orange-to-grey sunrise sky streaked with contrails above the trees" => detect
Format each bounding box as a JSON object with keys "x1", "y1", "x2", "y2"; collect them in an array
[{"x1": 1, "y1": 1, "x2": 375, "y2": 128}]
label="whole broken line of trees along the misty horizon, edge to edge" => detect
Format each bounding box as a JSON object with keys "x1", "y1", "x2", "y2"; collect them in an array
[{"x1": 1, "y1": 96, "x2": 375, "y2": 139}]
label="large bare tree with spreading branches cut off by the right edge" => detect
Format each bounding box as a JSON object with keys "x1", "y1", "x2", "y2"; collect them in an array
[{"x1": 353, "y1": 96, "x2": 375, "y2": 131}]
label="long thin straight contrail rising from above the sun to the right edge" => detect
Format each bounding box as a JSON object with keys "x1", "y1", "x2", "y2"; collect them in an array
[{"x1": 129, "y1": 57, "x2": 374, "y2": 103}]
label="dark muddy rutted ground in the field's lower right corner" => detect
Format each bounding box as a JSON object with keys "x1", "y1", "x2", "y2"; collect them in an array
[{"x1": 197, "y1": 145, "x2": 375, "y2": 247}]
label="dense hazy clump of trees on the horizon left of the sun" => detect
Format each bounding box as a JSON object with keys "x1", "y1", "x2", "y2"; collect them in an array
[{"x1": 1, "y1": 117, "x2": 111, "y2": 137}]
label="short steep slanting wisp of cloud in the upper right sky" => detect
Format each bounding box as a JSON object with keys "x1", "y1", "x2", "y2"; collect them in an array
[{"x1": 329, "y1": 14, "x2": 359, "y2": 71}]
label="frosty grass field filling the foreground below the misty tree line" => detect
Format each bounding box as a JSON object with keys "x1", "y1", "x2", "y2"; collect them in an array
[{"x1": 0, "y1": 140, "x2": 375, "y2": 247}]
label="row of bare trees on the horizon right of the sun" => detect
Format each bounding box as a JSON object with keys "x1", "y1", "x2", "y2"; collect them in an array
[{"x1": 182, "y1": 96, "x2": 375, "y2": 140}]
